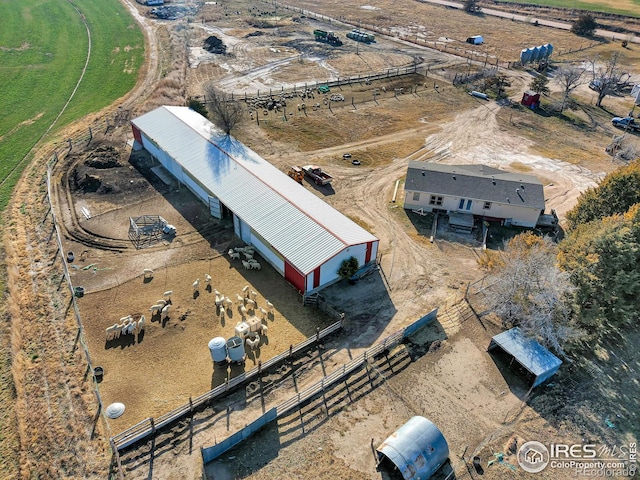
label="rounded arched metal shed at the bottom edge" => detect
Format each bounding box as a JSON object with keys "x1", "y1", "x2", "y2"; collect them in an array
[{"x1": 376, "y1": 416, "x2": 449, "y2": 480}]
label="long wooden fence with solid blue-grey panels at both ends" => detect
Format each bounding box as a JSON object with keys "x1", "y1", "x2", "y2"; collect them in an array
[{"x1": 200, "y1": 308, "x2": 438, "y2": 465}]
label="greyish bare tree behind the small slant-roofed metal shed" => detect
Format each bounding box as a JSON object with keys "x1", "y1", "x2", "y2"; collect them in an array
[{"x1": 484, "y1": 233, "x2": 576, "y2": 355}]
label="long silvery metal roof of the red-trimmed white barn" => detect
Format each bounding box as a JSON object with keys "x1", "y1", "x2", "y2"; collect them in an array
[{"x1": 131, "y1": 106, "x2": 378, "y2": 275}]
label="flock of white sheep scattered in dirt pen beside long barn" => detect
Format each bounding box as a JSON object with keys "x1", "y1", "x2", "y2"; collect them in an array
[{"x1": 106, "y1": 246, "x2": 274, "y2": 348}]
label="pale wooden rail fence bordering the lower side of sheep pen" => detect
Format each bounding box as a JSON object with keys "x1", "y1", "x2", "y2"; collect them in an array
[{"x1": 111, "y1": 320, "x2": 343, "y2": 451}]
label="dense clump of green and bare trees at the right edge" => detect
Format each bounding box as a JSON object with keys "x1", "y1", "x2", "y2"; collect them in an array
[{"x1": 480, "y1": 159, "x2": 640, "y2": 355}]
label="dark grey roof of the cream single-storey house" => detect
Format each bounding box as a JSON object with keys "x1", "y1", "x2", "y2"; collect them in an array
[{"x1": 405, "y1": 161, "x2": 544, "y2": 210}]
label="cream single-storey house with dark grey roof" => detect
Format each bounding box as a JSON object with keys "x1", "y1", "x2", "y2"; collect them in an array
[{"x1": 404, "y1": 161, "x2": 545, "y2": 227}]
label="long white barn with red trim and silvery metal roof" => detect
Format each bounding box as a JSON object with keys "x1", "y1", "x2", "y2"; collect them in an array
[{"x1": 131, "y1": 106, "x2": 378, "y2": 293}]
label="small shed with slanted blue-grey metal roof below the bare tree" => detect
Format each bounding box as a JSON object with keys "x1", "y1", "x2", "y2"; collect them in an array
[{"x1": 487, "y1": 327, "x2": 562, "y2": 387}]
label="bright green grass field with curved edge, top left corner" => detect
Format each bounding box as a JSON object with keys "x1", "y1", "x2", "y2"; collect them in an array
[{"x1": 0, "y1": 0, "x2": 144, "y2": 210}]
